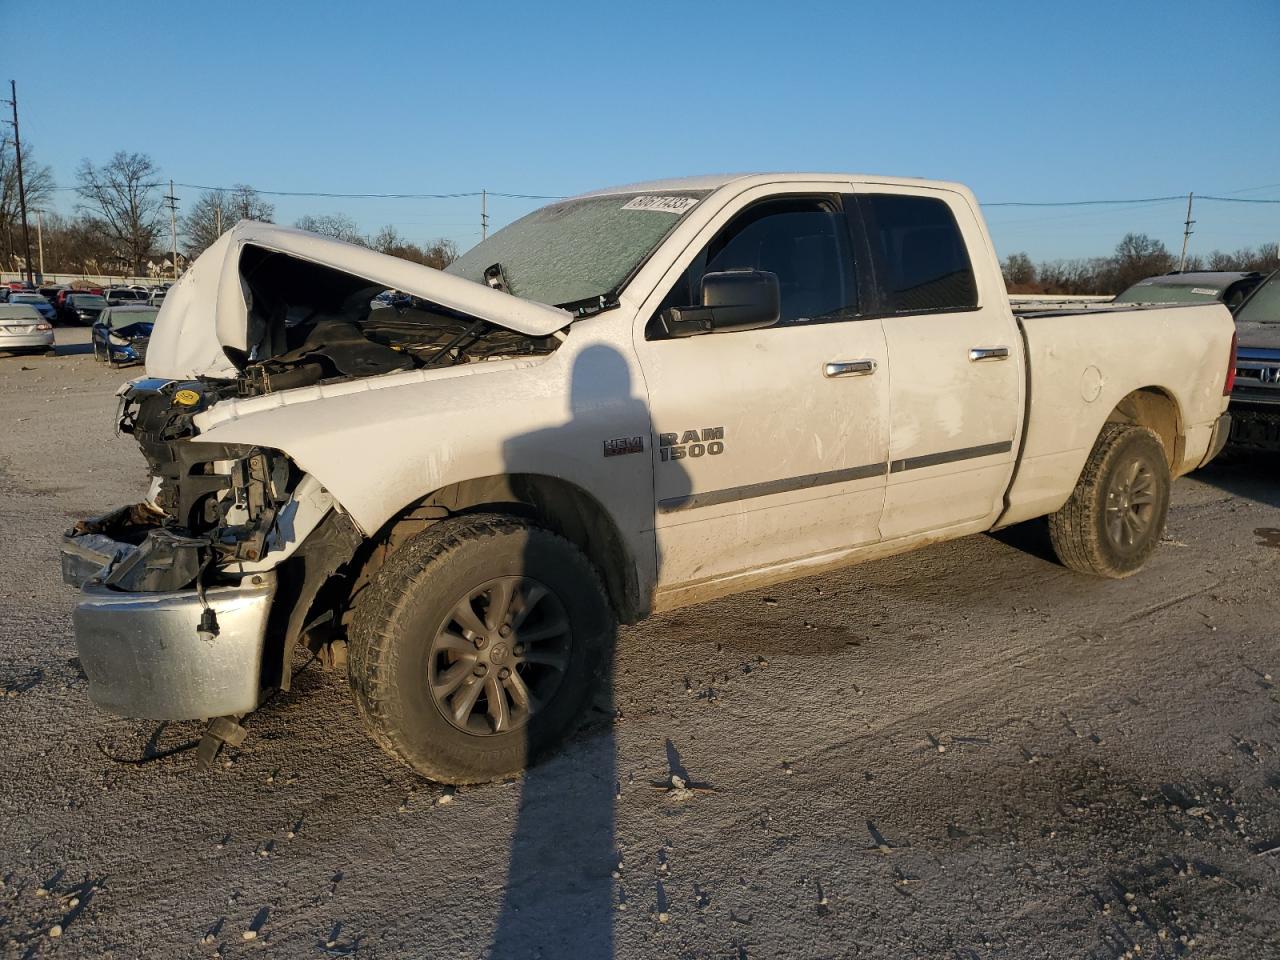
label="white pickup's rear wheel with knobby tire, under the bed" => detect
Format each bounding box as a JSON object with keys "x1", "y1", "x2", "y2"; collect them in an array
[{"x1": 1048, "y1": 424, "x2": 1172, "y2": 579}]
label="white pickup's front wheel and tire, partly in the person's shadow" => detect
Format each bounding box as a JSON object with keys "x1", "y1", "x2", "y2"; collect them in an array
[{"x1": 347, "y1": 515, "x2": 614, "y2": 783}]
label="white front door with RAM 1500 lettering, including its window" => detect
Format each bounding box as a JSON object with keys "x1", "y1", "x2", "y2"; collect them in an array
[{"x1": 636, "y1": 184, "x2": 890, "y2": 588}]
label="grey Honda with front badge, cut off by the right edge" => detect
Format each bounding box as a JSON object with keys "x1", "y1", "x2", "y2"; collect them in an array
[{"x1": 1230, "y1": 270, "x2": 1280, "y2": 452}]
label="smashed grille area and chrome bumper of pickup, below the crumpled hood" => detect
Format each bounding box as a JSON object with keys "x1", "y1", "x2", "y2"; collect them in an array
[{"x1": 61, "y1": 379, "x2": 360, "y2": 719}]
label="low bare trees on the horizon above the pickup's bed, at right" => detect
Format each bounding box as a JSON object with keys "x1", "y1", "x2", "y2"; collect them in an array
[{"x1": 1001, "y1": 233, "x2": 1280, "y2": 294}]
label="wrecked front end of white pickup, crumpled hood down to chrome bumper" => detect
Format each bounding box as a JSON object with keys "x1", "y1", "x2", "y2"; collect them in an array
[{"x1": 61, "y1": 221, "x2": 572, "y2": 719}]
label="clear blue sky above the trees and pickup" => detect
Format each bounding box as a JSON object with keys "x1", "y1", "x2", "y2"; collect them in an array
[{"x1": 10, "y1": 0, "x2": 1280, "y2": 259}]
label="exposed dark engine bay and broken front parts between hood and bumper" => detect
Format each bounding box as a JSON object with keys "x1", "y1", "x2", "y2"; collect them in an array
[{"x1": 64, "y1": 244, "x2": 563, "y2": 593}]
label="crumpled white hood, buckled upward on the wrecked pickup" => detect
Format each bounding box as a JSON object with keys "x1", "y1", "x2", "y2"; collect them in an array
[{"x1": 147, "y1": 220, "x2": 572, "y2": 380}]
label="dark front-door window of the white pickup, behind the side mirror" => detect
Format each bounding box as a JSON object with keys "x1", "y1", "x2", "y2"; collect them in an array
[{"x1": 645, "y1": 197, "x2": 859, "y2": 339}]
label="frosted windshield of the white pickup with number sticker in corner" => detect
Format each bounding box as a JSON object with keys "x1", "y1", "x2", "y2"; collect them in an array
[{"x1": 445, "y1": 191, "x2": 707, "y2": 306}]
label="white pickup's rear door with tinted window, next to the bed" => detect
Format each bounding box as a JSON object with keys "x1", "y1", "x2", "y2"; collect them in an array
[{"x1": 855, "y1": 184, "x2": 1024, "y2": 540}]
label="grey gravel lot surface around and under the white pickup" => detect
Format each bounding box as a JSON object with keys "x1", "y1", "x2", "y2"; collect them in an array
[{"x1": 0, "y1": 329, "x2": 1280, "y2": 960}]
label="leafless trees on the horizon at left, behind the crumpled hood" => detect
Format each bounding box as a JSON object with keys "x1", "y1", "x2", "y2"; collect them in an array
[{"x1": 0, "y1": 140, "x2": 458, "y2": 276}]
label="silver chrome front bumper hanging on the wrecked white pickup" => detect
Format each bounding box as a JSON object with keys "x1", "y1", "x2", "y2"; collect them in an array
[{"x1": 74, "y1": 572, "x2": 275, "y2": 719}]
